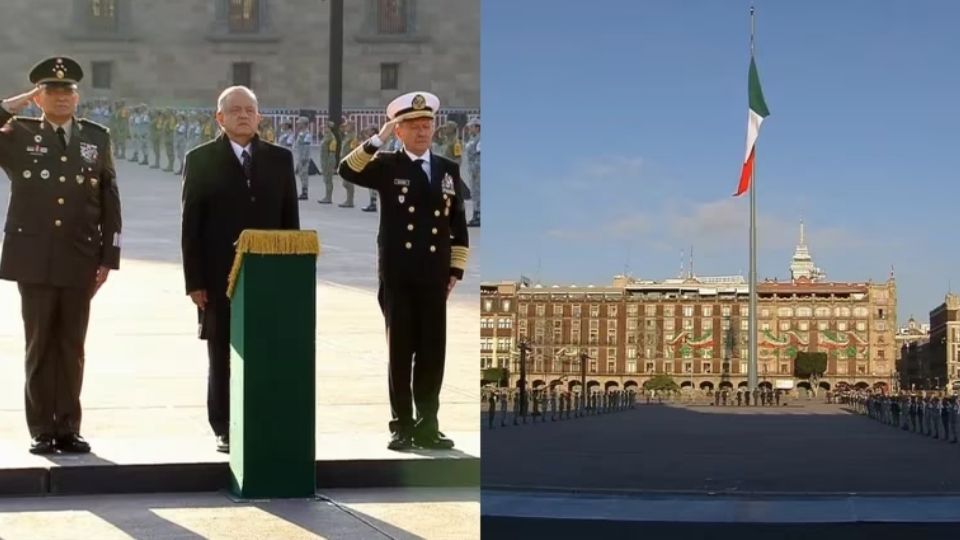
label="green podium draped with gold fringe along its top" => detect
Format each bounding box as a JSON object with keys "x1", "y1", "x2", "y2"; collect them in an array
[{"x1": 227, "y1": 230, "x2": 320, "y2": 499}]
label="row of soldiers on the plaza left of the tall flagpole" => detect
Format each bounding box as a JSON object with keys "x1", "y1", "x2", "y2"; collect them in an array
[{"x1": 486, "y1": 389, "x2": 637, "y2": 429}]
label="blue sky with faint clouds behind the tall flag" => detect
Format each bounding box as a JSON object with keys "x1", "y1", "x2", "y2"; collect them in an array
[{"x1": 481, "y1": 0, "x2": 960, "y2": 324}]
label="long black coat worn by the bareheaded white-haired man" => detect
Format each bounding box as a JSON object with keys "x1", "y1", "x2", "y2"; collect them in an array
[{"x1": 181, "y1": 134, "x2": 300, "y2": 336}]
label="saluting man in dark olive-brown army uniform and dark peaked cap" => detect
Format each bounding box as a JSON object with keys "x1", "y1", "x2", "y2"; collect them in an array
[{"x1": 0, "y1": 57, "x2": 121, "y2": 454}]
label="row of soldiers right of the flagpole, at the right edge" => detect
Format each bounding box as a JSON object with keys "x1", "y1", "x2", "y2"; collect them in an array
[{"x1": 841, "y1": 392, "x2": 960, "y2": 444}]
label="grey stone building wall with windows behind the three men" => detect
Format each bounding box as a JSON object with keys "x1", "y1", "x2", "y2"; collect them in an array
[{"x1": 0, "y1": 0, "x2": 480, "y2": 109}]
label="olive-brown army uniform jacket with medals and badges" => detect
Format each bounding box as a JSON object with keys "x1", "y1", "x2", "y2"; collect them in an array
[{"x1": 0, "y1": 108, "x2": 121, "y2": 287}]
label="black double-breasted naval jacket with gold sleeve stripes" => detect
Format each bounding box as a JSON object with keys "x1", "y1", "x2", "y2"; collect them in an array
[{"x1": 338, "y1": 144, "x2": 469, "y2": 287}]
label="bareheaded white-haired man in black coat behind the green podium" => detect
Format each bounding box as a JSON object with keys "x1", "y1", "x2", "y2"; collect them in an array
[{"x1": 181, "y1": 86, "x2": 300, "y2": 452}]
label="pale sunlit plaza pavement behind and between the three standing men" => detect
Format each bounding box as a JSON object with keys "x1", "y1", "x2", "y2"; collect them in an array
[{"x1": 0, "y1": 162, "x2": 480, "y2": 468}]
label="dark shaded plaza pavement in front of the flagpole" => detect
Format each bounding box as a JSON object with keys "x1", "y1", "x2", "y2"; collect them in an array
[{"x1": 481, "y1": 401, "x2": 960, "y2": 494}]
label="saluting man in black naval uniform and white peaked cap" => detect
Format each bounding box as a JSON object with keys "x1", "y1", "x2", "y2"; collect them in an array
[{"x1": 339, "y1": 92, "x2": 468, "y2": 450}]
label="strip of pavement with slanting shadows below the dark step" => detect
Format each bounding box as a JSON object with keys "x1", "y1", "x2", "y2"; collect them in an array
[{"x1": 0, "y1": 489, "x2": 480, "y2": 540}]
